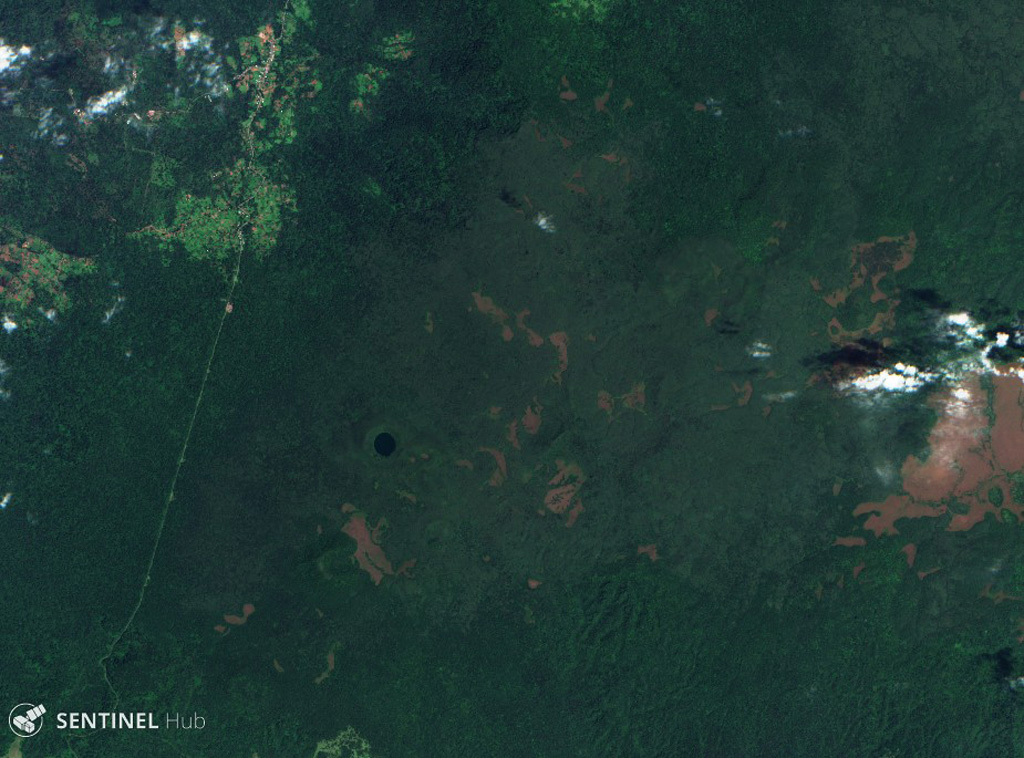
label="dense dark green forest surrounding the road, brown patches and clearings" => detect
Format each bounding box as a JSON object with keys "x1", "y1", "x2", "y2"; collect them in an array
[{"x1": 6, "y1": 0, "x2": 1024, "y2": 758}]
